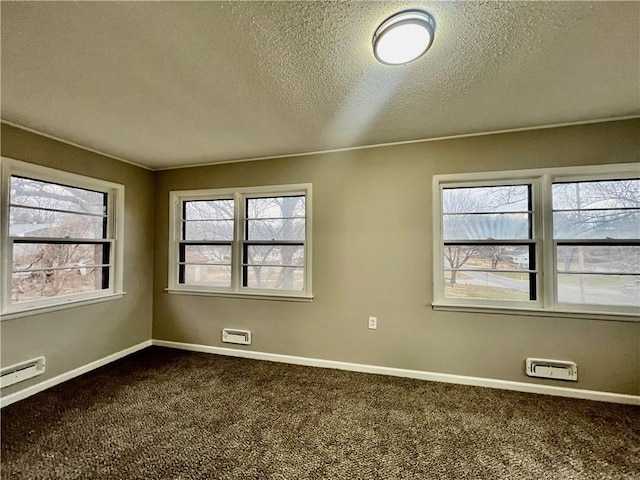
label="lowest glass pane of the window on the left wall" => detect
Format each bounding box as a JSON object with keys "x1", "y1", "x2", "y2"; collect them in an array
[{"x1": 11, "y1": 266, "x2": 103, "y2": 302}]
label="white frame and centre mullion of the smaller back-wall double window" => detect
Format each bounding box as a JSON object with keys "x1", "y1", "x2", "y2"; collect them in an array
[{"x1": 166, "y1": 183, "x2": 313, "y2": 301}]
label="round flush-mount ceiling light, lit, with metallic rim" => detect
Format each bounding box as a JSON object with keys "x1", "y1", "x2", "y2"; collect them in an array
[{"x1": 373, "y1": 10, "x2": 436, "y2": 65}]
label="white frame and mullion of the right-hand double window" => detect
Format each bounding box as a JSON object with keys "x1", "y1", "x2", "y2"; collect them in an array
[{"x1": 432, "y1": 163, "x2": 640, "y2": 322}]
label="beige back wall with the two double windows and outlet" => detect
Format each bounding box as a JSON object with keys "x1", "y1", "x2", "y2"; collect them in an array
[{"x1": 153, "y1": 120, "x2": 640, "y2": 394}]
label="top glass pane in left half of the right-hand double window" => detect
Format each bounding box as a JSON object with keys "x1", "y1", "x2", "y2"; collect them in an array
[{"x1": 442, "y1": 185, "x2": 529, "y2": 213}]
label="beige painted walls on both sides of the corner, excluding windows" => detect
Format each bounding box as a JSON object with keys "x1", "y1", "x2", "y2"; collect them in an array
[{"x1": 0, "y1": 120, "x2": 640, "y2": 402}]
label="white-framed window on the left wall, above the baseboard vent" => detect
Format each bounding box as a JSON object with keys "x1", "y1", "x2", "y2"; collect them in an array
[{"x1": 2, "y1": 159, "x2": 124, "y2": 315}]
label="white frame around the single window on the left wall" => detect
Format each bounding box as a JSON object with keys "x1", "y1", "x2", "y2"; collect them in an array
[{"x1": 0, "y1": 157, "x2": 125, "y2": 320}]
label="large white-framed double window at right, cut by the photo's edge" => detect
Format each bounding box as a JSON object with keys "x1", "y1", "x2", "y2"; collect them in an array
[{"x1": 434, "y1": 165, "x2": 640, "y2": 316}]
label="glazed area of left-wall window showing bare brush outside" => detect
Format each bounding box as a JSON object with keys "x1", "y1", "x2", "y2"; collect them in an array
[{"x1": 9, "y1": 176, "x2": 110, "y2": 303}]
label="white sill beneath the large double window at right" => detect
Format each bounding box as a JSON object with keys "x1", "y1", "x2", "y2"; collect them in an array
[{"x1": 431, "y1": 303, "x2": 640, "y2": 323}]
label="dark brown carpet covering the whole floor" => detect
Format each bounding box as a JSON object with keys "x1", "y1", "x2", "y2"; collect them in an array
[{"x1": 1, "y1": 347, "x2": 640, "y2": 480}]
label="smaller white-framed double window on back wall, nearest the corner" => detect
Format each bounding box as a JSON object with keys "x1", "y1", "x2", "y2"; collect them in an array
[{"x1": 168, "y1": 184, "x2": 311, "y2": 299}]
